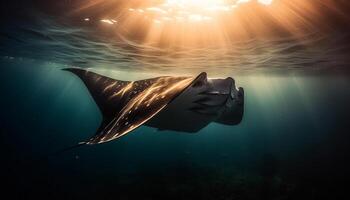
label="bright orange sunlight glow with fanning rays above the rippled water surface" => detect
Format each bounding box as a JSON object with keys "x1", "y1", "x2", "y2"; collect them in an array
[{"x1": 68, "y1": 0, "x2": 348, "y2": 47}]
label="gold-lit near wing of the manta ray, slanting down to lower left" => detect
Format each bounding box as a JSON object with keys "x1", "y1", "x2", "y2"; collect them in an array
[{"x1": 87, "y1": 77, "x2": 205, "y2": 144}]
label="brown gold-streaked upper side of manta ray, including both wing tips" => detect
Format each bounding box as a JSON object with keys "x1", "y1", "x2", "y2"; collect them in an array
[{"x1": 66, "y1": 68, "x2": 206, "y2": 144}]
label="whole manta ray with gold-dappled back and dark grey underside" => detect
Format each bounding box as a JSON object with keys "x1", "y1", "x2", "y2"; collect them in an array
[{"x1": 63, "y1": 68, "x2": 244, "y2": 145}]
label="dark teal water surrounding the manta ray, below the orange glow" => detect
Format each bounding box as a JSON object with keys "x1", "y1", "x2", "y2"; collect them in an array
[{"x1": 0, "y1": 2, "x2": 350, "y2": 199}]
